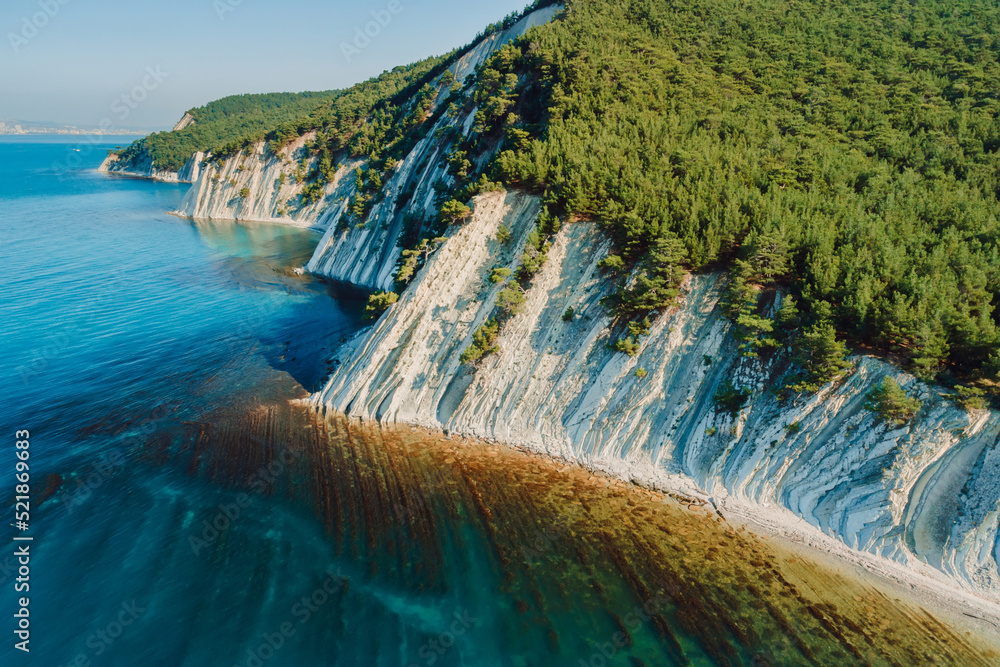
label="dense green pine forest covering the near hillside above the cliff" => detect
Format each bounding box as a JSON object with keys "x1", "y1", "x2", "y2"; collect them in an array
[{"x1": 494, "y1": 0, "x2": 1000, "y2": 387}]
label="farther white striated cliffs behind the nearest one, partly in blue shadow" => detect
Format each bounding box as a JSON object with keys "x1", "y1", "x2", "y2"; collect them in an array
[{"x1": 170, "y1": 6, "x2": 561, "y2": 290}]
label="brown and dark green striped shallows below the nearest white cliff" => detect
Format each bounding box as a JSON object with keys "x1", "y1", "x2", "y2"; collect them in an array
[{"x1": 156, "y1": 405, "x2": 1000, "y2": 666}]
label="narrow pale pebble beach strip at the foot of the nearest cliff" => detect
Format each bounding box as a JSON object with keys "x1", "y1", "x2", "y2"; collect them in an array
[{"x1": 330, "y1": 412, "x2": 1000, "y2": 653}]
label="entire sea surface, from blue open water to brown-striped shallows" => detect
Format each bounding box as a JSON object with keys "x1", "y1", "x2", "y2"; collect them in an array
[{"x1": 0, "y1": 138, "x2": 1000, "y2": 667}]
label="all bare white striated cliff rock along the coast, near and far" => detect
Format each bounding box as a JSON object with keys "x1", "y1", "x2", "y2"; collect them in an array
[{"x1": 95, "y1": 0, "x2": 1000, "y2": 624}]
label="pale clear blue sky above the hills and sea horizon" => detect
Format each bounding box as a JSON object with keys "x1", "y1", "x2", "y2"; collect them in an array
[{"x1": 0, "y1": 0, "x2": 528, "y2": 129}]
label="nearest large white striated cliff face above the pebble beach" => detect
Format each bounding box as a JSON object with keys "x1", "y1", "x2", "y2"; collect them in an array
[{"x1": 313, "y1": 193, "x2": 1000, "y2": 600}]
